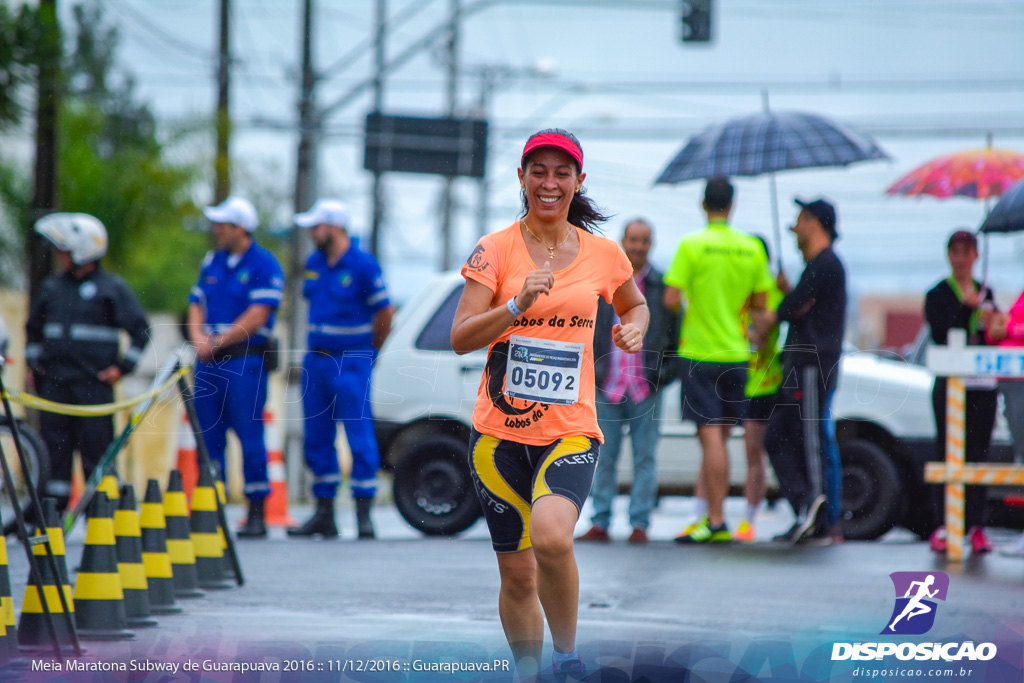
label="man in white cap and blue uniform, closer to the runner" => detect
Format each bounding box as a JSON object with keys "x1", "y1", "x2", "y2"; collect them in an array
[{"x1": 288, "y1": 200, "x2": 394, "y2": 539}]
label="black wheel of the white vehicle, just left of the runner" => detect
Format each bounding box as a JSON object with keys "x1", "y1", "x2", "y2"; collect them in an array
[{"x1": 393, "y1": 434, "x2": 483, "y2": 536}]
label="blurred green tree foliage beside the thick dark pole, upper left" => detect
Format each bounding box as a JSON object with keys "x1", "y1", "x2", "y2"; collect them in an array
[{"x1": 0, "y1": 0, "x2": 207, "y2": 310}]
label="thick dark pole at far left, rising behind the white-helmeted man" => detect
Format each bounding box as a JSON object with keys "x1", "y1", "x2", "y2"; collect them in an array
[{"x1": 29, "y1": 0, "x2": 61, "y2": 300}]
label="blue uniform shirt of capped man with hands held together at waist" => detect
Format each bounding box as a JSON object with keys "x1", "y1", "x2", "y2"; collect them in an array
[{"x1": 188, "y1": 242, "x2": 285, "y2": 344}]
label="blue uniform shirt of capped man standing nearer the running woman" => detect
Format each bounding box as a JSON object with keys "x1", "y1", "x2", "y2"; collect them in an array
[{"x1": 302, "y1": 243, "x2": 390, "y2": 351}]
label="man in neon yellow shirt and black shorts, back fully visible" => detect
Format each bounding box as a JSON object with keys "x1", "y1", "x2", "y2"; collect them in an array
[{"x1": 665, "y1": 176, "x2": 772, "y2": 544}]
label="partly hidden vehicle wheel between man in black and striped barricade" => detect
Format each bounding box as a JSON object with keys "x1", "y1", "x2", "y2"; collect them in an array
[{"x1": 839, "y1": 438, "x2": 902, "y2": 540}]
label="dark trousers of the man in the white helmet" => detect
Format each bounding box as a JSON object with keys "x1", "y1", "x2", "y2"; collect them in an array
[{"x1": 37, "y1": 375, "x2": 114, "y2": 512}]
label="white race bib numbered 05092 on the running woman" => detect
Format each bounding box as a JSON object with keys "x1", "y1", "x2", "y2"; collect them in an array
[{"x1": 505, "y1": 335, "x2": 584, "y2": 405}]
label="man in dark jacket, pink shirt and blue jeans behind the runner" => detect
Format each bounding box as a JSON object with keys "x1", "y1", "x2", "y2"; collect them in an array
[{"x1": 580, "y1": 219, "x2": 679, "y2": 543}]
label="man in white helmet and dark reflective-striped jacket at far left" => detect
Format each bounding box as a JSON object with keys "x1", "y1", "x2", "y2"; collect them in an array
[{"x1": 25, "y1": 213, "x2": 150, "y2": 512}]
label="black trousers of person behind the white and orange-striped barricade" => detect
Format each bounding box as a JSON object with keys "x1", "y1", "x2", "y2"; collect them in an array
[{"x1": 930, "y1": 377, "x2": 998, "y2": 528}]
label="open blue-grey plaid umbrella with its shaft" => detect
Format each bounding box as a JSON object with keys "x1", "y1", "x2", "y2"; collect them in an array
[{"x1": 655, "y1": 105, "x2": 889, "y2": 266}]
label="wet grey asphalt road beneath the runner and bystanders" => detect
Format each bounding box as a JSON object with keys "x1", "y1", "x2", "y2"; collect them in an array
[{"x1": 2, "y1": 497, "x2": 1024, "y2": 680}]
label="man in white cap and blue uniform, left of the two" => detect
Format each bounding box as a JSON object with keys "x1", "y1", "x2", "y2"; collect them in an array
[{"x1": 188, "y1": 197, "x2": 285, "y2": 538}]
